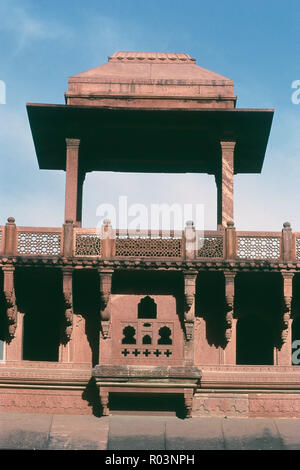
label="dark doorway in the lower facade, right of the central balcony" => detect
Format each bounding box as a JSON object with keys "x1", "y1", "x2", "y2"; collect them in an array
[{"x1": 236, "y1": 314, "x2": 274, "y2": 365}]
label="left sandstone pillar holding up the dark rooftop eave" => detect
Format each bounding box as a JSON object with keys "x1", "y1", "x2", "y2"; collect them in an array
[{"x1": 65, "y1": 139, "x2": 85, "y2": 227}]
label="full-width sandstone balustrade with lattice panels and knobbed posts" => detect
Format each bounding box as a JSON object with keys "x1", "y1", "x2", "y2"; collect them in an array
[{"x1": 0, "y1": 217, "x2": 300, "y2": 262}]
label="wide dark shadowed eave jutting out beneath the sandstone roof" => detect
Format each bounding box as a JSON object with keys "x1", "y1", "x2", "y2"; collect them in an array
[{"x1": 27, "y1": 103, "x2": 274, "y2": 174}]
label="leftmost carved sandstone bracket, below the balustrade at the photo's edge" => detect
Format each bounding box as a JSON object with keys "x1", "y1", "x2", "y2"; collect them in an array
[{"x1": 2, "y1": 265, "x2": 18, "y2": 342}]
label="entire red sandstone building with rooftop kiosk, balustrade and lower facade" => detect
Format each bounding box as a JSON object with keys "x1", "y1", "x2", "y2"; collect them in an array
[{"x1": 0, "y1": 52, "x2": 300, "y2": 417}]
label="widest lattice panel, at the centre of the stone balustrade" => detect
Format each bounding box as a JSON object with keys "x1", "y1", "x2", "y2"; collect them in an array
[{"x1": 116, "y1": 237, "x2": 182, "y2": 258}]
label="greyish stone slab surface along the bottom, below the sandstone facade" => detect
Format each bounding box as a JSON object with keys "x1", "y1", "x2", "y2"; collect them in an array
[{"x1": 0, "y1": 413, "x2": 300, "y2": 450}]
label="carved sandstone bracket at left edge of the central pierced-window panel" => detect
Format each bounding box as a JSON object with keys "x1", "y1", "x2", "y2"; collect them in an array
[{"x1": 99, "y1": 269, "x2": 113, "y2": 339}]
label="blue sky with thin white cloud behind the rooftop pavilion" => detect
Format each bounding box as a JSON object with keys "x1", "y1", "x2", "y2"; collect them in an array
[{"x1": 0, "y1": 0, "x2": 300, "y2": 231}]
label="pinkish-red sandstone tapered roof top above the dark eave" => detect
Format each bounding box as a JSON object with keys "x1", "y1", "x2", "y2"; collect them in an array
[{"x1": 65, "y1": 52, "x2": 236, "y2": 109}]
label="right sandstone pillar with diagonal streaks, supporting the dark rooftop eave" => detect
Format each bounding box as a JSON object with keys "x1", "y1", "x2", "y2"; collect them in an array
[{"x1": 215, "y1": 141, "x2": 235, "y2": 228}]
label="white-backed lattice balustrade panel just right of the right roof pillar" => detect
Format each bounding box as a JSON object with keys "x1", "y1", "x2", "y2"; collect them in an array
[{"x1": 237, "y1": 236, "x2": 280, "y2": 259}]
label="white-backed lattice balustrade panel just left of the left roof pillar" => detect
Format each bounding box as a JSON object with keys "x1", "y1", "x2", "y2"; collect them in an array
[{"x1": 18, "y1": 232, "x2": 61, "y2": 256}]
